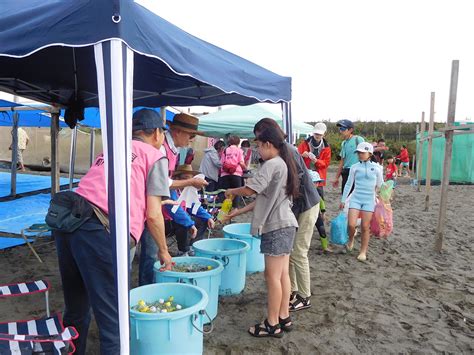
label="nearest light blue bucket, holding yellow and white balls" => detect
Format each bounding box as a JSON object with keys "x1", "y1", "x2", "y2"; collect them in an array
[{"x1": 130, "y1": 283, "x2": 208, "y2": 355}]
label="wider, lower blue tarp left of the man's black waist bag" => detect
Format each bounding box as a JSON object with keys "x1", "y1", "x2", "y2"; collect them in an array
[{"x1": 0, "y1": 194, "x2": 51, "y2": 234}]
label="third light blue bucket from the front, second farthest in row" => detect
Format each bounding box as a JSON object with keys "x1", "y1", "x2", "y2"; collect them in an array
[{"x1": 193, "y1": 238, "x2": 250, "y2": 296}]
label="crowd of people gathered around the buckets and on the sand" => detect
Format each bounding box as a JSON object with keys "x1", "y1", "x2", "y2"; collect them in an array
[{"x1": 48, "y1": 109, "x2": 406, "y2": 354}]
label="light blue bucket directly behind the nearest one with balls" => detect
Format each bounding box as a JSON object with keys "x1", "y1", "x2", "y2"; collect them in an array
[{"x1": 153, "y1": 257, "x2": 224, "y2": 320}]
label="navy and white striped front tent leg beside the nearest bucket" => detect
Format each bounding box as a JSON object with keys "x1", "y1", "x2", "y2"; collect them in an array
[{"x1": 94, "y1": 39, "x2": 133, "y2": 355}]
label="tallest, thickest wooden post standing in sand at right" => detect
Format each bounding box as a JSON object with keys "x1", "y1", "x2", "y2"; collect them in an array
[{"x1": 435, "y1": 60, "x2": 459, "y2": 252}]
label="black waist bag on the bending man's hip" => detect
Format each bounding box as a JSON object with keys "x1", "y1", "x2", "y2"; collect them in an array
[{"x1": 45, "y1": 191, "x2": 94, "y2": 233}]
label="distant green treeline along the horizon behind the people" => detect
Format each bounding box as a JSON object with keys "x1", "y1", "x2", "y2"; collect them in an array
[{"x1": 307, "y1": 122, "x2": 444, "y2": 160}]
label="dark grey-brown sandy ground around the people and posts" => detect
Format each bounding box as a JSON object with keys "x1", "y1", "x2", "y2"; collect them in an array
[{"x1": 0, "y1": 174, "x2": 474, "y2": 354}]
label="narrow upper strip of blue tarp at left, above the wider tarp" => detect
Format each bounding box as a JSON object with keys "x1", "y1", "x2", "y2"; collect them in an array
[{"x1": 0, "y1": 172, "x2": 79, "y2": 197}]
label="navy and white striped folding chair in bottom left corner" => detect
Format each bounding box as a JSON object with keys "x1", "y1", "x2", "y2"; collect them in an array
[{"x1": 0, "y1": 280, "x2": 79, "y2": 355}]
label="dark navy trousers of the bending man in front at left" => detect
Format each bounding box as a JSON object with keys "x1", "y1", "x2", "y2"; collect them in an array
[{"x1": 53, "y1": 216, "x2": 120, "y2": 355}]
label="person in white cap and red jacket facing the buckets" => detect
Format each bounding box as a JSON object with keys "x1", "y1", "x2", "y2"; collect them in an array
[{"x1": 298, "y1": 122, "x2": 331, "y2": 252}]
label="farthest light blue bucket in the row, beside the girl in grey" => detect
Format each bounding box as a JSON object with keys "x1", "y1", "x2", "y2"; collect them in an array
[{"x1": 223, "y1": 223, "x2": 265, "y2": 274}]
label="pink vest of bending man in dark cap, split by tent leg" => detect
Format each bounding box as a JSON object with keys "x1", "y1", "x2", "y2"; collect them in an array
[{"x1": 76, "y1": 140, "x2": 163, "y2": 243}]
